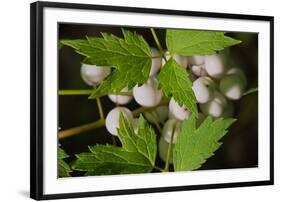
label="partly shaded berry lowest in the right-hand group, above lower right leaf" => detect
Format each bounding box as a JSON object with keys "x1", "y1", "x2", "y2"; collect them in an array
[{"x1": 200, "y1": 92, "x2": 227, "y2": 118}]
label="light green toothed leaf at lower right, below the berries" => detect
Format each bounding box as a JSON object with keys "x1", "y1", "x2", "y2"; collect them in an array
[{"x1": 174, "y1": 116, "x2": 236, "y2": 171}]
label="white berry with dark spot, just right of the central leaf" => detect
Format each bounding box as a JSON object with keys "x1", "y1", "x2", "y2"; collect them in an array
[{"x1": 192, "y1": 76, "x2": 215, "y2": 103}]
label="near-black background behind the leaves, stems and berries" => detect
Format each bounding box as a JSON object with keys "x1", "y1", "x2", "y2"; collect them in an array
[{"x1": 58, "y1": 24, "x2": 258, "y2": 176}]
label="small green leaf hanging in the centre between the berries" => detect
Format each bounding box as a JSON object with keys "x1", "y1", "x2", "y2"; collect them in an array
[{"x1": 158, "y1": 58, "x2": 198, "y2": 117}]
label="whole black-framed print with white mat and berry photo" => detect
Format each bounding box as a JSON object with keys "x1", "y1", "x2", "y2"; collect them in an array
[{"x1": 31, "y1": 2, "x2": 273, "y2": 200}]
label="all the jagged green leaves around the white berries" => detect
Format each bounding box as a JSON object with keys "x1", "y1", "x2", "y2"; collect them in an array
[{"x1": 58, "y1": 29, "x2": 244, "y2": 177}]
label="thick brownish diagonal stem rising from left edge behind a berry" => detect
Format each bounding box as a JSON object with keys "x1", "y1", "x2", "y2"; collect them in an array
[{"x1": 59, "y1": 100, "x2": 168, "y2": 139}]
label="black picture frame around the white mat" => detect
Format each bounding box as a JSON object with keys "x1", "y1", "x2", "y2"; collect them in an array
[{"x1": 30, "y1": 2, "x2": 274, "y2": 200}]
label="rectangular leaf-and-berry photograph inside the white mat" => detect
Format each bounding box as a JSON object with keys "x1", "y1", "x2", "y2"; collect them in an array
[{"x1": 57, "y1": 22, "x2": 259, "y2": 178}]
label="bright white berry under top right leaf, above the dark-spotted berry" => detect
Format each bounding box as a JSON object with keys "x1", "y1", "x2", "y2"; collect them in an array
[{"x1": 202, "y1": 55, "x2": 225, "y2": 79}]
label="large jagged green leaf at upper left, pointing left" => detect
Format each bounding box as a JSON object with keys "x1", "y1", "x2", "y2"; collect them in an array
[{"x1": 61, "y1": 30, "x2": 152, "y2": 99}]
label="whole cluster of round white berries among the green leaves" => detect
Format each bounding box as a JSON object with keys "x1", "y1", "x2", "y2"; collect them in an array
[{"x1": 81, "y1": 48, "x2": 247, "y2": 163}]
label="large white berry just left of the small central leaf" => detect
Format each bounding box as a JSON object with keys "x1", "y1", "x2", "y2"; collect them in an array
[{"x1": 133, "y1": 77, "x2": 163, "y2": 107}]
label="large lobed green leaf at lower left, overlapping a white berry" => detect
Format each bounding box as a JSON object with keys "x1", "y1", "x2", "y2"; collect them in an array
[{"x1": 72, "y1": 114, "x2": 157, "y2": 175}]
